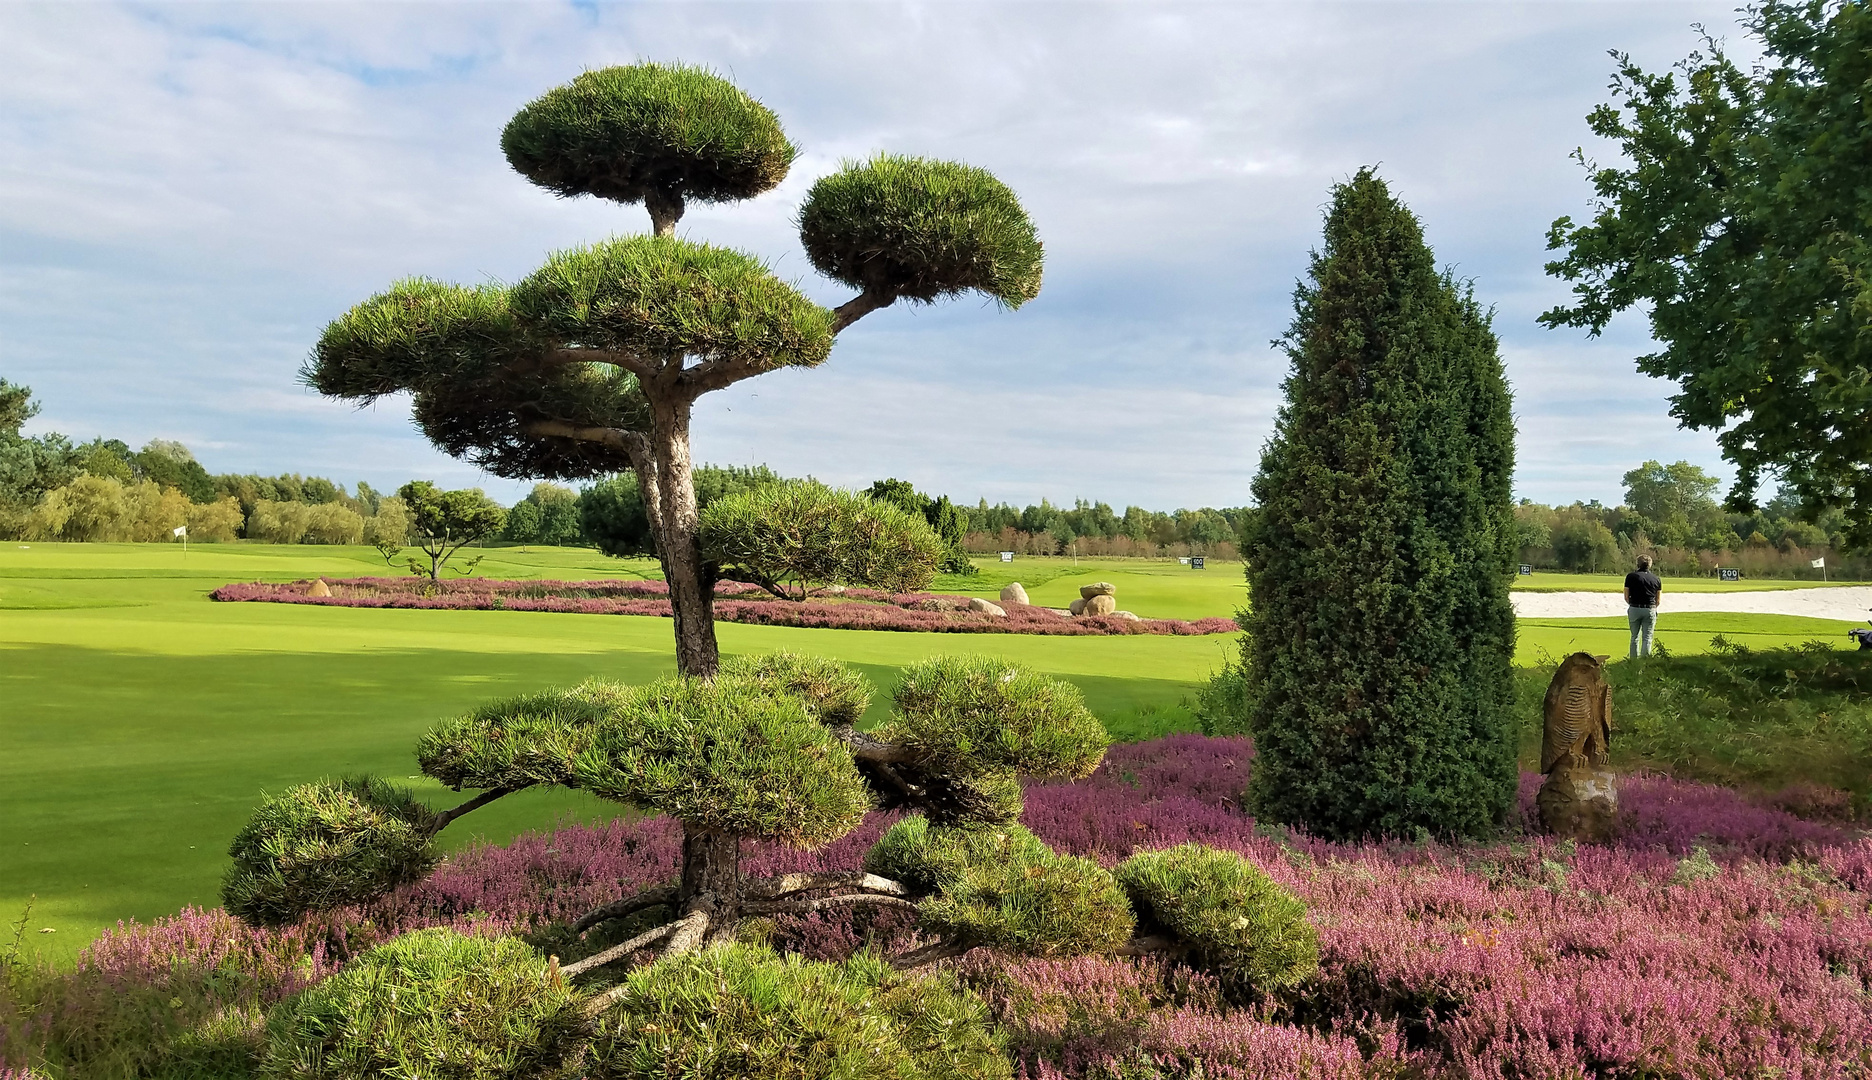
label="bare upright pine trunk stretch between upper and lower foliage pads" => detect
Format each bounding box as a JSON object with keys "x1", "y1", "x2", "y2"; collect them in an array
[{"x1": 646, "y1": 391, "x2": 721, "y2": 678}]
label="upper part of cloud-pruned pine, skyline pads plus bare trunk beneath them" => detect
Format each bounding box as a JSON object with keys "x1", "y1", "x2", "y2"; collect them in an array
[{"x1": 305, "y1": 64, "x2": 1041, "y2": 676}]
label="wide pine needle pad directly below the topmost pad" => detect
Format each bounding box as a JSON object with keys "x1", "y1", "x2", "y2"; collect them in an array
[{"x1": 513, "y1": 236, "x2": 831, "y2": 372}]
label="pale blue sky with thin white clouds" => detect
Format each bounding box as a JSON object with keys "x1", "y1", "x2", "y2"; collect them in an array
[{"x1": 0, "y1": 0, "x2": 1747, "y2": 509}]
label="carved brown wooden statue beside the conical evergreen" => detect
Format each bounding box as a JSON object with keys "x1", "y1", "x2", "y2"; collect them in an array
[{"x1": 1535, "y1": 653, "x2": 1619, "y2": 842}]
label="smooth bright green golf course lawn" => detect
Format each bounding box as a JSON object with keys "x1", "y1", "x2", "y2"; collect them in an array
[{"x1": 0, "y1": 545, "x2": 1848, "y2": 956}]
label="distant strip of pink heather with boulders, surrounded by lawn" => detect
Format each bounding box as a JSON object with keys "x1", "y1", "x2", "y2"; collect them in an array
[{"x1": 208, "y1": 578, "x2": 1236, "y2": 636}]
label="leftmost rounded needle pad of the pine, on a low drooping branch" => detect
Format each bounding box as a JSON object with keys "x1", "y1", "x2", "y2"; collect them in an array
[{"x1": 221, "y1": 777, "x2": 438, "y2": 927}]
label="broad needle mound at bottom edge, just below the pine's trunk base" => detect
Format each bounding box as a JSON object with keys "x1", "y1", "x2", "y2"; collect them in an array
[{"x1": 586, "y1": 945, "x2": 1013, "y2": 1080}]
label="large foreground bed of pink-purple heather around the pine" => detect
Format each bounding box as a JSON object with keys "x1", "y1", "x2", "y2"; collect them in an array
[{"x1": 18, "y1": 736, "x2": 1872, "y2": 1080}]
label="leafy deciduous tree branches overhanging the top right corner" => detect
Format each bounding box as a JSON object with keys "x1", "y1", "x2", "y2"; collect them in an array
[{"x1": 1541, "y1": 0, "x2": 1872, "y2": 545}]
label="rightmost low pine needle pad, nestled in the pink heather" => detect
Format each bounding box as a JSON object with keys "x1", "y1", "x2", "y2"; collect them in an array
[{"x1": 1116, "y1": 844, "x2": 1320, "y2": 992}]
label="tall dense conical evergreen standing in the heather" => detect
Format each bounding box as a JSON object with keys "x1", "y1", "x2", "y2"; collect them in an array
[{"x1": 1243, "y1": 168, "x2": 1516, "y2": 839}]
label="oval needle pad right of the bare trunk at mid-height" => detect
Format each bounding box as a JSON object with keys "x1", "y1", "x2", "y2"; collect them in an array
[{"x1": 702, "y1": 481, "x2": 943, "y2": 599}]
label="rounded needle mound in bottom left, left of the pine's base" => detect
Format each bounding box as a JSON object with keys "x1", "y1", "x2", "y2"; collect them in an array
[{"x1": 262, "y1": 927, "x2": 582, "y2": 1080}]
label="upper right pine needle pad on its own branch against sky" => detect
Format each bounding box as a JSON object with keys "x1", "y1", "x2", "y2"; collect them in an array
[{"x1": 799, "y1": 153, "x2": 1043, "y2": 307}]
